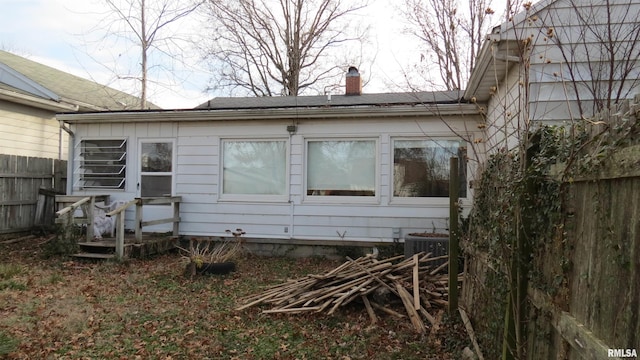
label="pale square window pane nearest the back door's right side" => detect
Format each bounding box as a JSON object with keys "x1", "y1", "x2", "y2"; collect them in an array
[{"x1": 222, "y1": 140, "x2": 287, "y2": 195}]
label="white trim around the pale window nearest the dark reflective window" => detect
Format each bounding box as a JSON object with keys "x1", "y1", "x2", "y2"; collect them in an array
[{"x1": 302, "y1": 136, "x2": 381, "y2": 204}]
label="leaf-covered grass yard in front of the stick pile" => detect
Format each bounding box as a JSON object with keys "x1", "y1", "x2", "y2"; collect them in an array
[{"x1": 0, "y1": 238, "x2": 468, "y2": 360}]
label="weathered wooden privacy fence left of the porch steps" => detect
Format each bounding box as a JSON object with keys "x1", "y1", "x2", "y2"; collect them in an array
[{"x1": 0, "y1": 155, "x2": 67, "y2": 234}]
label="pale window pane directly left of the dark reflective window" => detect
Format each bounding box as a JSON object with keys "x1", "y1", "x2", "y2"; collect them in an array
[{"x1": 307, "y1": 140, "x2": 376, "y2": 196}]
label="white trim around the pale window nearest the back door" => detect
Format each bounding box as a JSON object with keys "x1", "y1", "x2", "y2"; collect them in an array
[{"x1": 218, "y1": 136, "x2": 291, "y2": 203}]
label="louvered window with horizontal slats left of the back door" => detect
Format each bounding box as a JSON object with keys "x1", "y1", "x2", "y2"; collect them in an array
[{"x1": 75, "y1": 139, "x2": 127, "y2": 189}]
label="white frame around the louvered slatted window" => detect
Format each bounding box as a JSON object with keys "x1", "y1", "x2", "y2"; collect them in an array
[{"x1": 73, "y1": 136, "x2": 131, "y2": 191}]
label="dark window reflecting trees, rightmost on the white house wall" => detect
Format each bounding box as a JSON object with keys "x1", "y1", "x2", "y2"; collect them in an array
[{"x1": 393, "y1": 140, "x2": 467, "y2": 197}]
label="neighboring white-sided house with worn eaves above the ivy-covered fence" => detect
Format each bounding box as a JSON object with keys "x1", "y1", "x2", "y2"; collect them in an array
[{"x1": 464, "y1": 0, "x2": 640, "y2": 153}]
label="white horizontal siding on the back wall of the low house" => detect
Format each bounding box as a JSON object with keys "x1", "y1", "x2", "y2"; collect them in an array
[{"x1": 73, "y1": 117, "x2": 479, "y2": 242}]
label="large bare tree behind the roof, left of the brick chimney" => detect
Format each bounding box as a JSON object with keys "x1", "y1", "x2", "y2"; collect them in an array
[{"x1": 202, "y1": 0, "x2": 366, "y2": 96}]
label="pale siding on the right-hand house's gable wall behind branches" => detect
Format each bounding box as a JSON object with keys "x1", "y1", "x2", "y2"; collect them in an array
[{"x1": 523, "y1": 0, "x2": 640, "y2": 124}]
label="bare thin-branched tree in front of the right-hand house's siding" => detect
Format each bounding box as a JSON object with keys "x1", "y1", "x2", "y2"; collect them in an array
[{"x1": 534, "y1": 0, "x2": 640, "y2": 119}]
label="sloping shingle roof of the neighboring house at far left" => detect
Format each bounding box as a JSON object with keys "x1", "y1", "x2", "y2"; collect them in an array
[{"x1": 0, "y1": 50, "x2": 159, "y2": 111}]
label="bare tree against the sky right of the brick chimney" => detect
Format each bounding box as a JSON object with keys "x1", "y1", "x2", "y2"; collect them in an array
[{"x1": 401, "y1": 0, "x2": 494, "y2": 90}]
